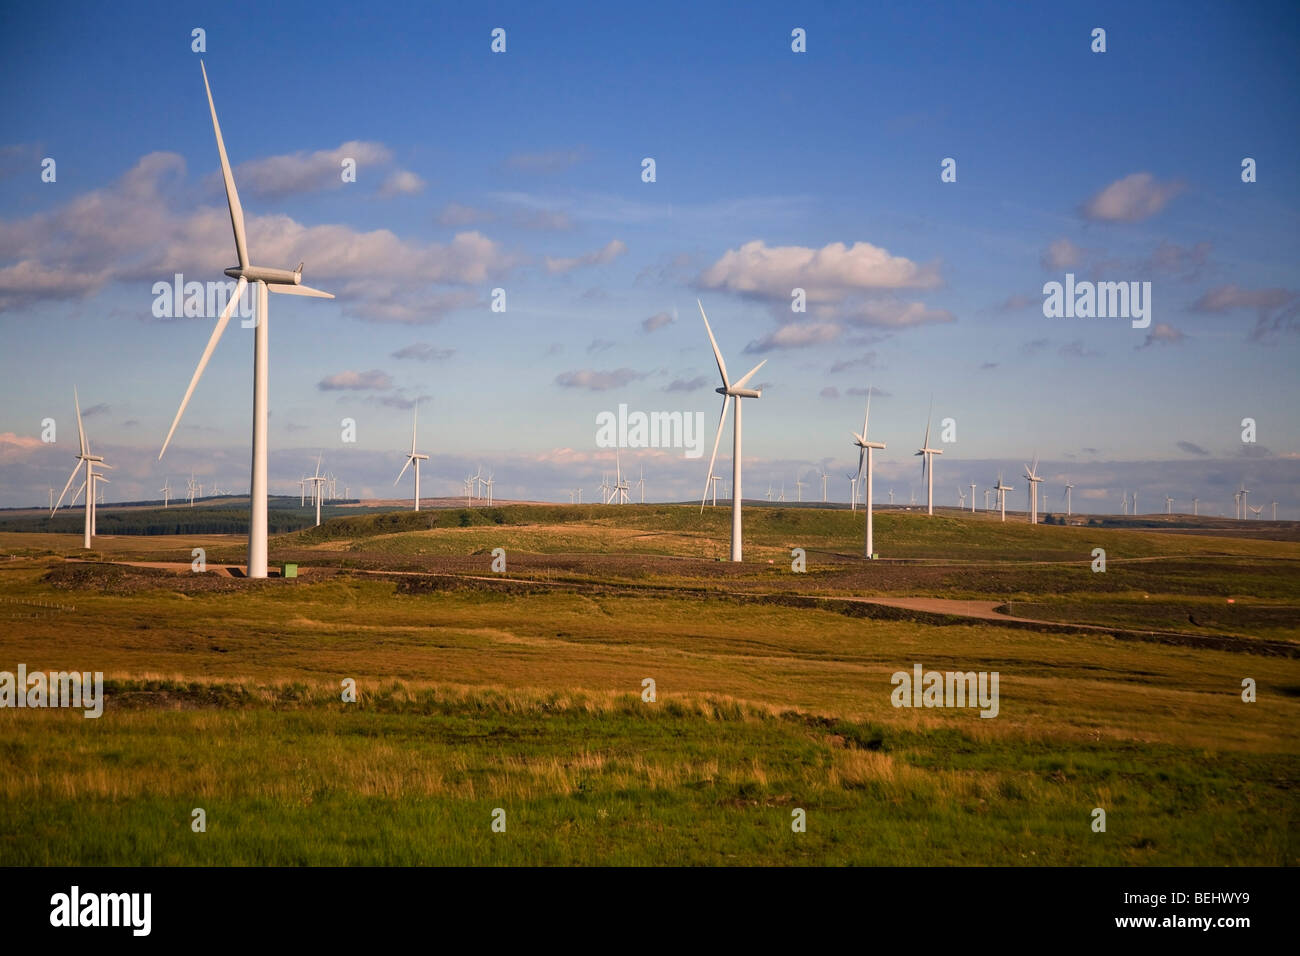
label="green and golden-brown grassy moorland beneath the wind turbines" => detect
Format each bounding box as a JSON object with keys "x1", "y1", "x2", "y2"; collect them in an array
[{"x1": 0, "y1": 506, "x2": 1300, "y2": 865}]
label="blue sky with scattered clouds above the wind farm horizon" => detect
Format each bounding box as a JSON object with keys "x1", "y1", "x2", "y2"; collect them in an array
[{"x1": 0, "y1": 3, "x2": 1300, "y2": 518}]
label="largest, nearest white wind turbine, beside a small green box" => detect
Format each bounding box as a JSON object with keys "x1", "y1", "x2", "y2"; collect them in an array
[{"x1": 159, "y1": 62, "x2": 334, "y2": 578}]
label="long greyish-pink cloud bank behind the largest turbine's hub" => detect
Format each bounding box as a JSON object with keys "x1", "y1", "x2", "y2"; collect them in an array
[{"x1": 0, "y1": 152, "x2": 520, "y2": 321}]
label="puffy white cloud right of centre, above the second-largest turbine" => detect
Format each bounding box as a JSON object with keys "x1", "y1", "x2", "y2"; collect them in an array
[{"x1": 698, "y1": 239, "x2": 940, "y2": 303}]
